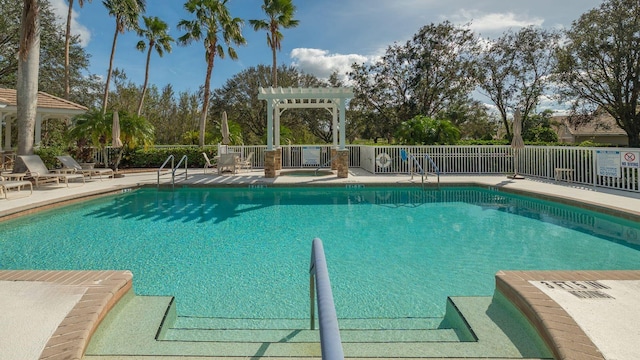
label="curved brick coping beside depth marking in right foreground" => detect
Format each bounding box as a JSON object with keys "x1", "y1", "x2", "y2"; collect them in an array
[{"x1": 495, "y1": 270, "x2": 640, "y2": 360}]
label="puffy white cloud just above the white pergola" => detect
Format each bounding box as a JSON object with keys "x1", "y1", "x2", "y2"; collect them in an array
[{"x1": 290, "y1": 48, "x2": 375, "y2": 82}]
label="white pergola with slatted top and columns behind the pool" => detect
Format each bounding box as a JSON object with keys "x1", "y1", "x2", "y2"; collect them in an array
[{"x1": 258, "y1": 87, "x2": 353, "y2": 151}]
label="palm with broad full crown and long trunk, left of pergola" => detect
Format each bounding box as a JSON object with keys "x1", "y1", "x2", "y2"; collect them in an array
[{"x1": 178, "y1": 0, "x2": 246, "y2": 146}]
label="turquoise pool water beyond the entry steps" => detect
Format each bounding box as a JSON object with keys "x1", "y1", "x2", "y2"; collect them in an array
[{"x1": 0, "y1": 188, "x2": 640, "y2": 318}]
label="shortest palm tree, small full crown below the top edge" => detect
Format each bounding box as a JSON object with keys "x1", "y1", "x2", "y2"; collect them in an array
[{"x1": 136, "y1": 16, "x2": 173, "y2": 116}]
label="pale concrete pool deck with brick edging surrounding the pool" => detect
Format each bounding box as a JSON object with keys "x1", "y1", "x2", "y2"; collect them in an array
[{"x1": 0, "y1": 169, "x2": 640, "y2": 359}]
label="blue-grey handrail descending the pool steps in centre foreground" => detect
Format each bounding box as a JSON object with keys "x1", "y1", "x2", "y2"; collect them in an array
[{"x1": 309, "y1": 238, "x2": 344, "y2": 360}]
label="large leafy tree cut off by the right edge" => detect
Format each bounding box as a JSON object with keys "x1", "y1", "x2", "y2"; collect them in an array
[{"x1": 556, "y1": 0, "x2": 640, "y2": 147}]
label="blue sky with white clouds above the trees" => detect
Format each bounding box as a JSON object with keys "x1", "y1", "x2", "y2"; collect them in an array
[{"x1": 50, "y1": 0, "x2": 602, "y2": 97}]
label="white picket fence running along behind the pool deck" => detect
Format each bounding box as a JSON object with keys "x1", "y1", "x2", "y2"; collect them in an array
[{"x1": 95, "y1": 145, "x2": 640, "y2": 192}]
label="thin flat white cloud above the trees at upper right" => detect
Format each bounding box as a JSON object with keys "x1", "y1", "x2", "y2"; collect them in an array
[{"x1": 451, "y1": 9, "x2": 544, "y2": 32}]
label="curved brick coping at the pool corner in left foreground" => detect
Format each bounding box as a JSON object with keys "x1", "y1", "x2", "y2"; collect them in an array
[{"x1": 0, "y1": 270, "x2": 133, "y2": 360}]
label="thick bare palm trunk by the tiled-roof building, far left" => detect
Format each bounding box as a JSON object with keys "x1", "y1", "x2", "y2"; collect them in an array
[{"x1": 16, "y1": 0, "x2": 40, "y2": 155}]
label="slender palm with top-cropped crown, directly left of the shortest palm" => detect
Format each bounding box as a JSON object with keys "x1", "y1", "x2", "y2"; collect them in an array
[{"x1": 102, "y1": 0, "x2": 145, "y2": 114}]
